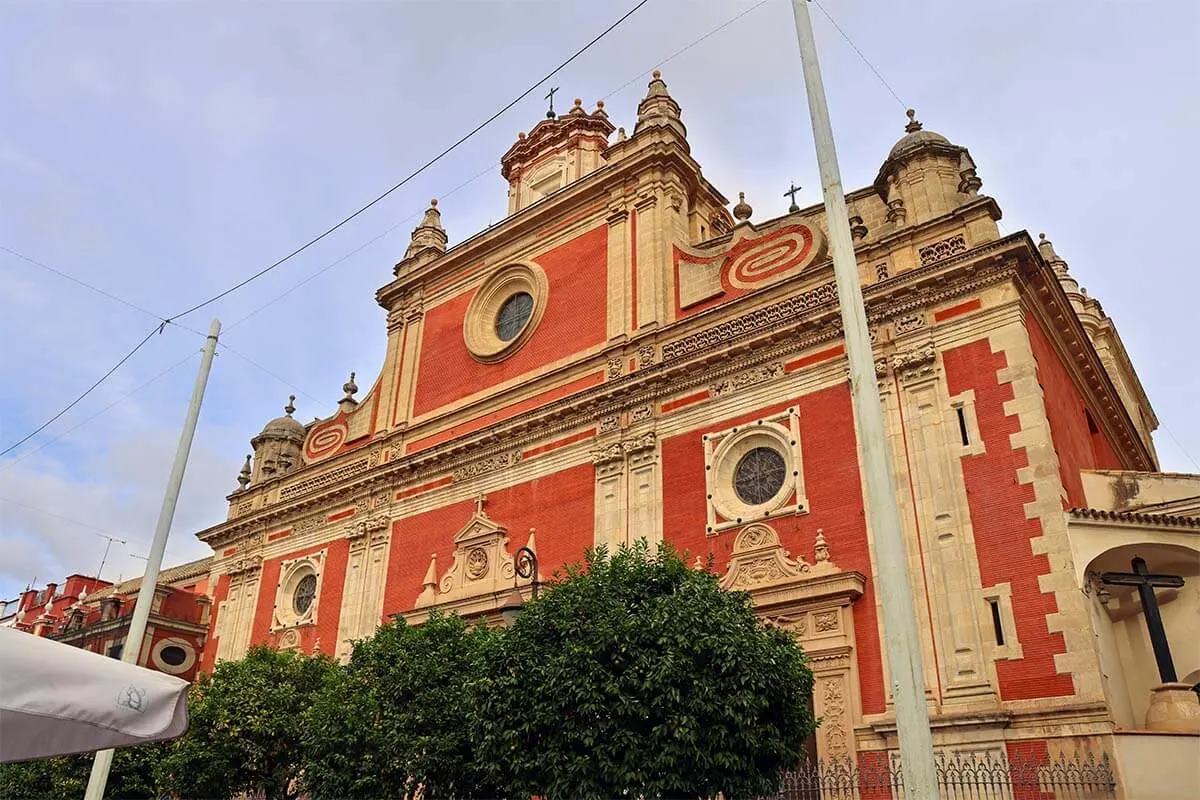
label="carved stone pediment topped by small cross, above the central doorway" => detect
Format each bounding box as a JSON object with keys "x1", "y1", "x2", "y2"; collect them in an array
[{"x1": 415, "y1": 511, "x2": 516, "y2": 608}]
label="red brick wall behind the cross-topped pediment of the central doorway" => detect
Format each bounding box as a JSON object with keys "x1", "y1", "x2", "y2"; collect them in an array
[{"x1": 383, "y1": 464, "x2": 595, "y2": 621}]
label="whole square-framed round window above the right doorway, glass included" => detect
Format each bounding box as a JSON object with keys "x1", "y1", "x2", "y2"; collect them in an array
[{"x1": 703, "y1": 409, "x2": 808, "y2": 535}]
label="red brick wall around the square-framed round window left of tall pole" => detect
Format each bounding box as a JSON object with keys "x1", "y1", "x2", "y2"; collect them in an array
[{"x1": 662, "y1": 385, "x2": 886, "y2": 714}]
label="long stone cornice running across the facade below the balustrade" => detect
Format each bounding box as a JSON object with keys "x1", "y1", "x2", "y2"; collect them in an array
[{"x1": 198, "y1": 235, "x2": 1028, "y2": 548}]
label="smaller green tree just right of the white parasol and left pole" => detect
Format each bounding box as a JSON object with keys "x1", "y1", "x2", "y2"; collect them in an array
[{"x1": 158, "y1": 646, "x2": 335, "y2": 800}]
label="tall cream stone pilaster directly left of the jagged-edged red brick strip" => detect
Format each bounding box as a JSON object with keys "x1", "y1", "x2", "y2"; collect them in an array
[{"x1": 892, "y1": 343, "x2": 996, "y2": 704}]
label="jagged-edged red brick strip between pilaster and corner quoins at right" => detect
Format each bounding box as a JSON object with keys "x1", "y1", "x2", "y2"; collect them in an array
[{"x1": 942, "y1": 341, "x2": 1074, "y2": 700}]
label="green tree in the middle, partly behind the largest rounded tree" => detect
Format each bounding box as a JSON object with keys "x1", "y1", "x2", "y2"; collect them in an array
[{"x1": 305, "y1": 613, "x2": 506, "y2": 799}]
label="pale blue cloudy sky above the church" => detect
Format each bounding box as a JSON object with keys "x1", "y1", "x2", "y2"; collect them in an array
[{"x1": 0, "y1": 0, "x2": 1200, "y2": 600}]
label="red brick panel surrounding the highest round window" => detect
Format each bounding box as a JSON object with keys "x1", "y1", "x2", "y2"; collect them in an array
[{"x1": 413, "y1": 227, "x2": 608, "y2": 416}]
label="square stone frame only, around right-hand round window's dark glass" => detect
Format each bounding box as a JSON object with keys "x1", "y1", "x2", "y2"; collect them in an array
[{"x1": 702, "y1": 407, "x2": 809, "y2": 536}]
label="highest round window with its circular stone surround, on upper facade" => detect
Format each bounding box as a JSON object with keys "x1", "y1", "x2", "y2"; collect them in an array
[{"x1": 462, "y1": 263, "x2": 547, "y2": 363}]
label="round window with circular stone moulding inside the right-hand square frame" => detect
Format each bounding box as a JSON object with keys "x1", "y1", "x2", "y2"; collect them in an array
[{"x1": 712, "y1": 425, "x2": 796, "y2": 522}]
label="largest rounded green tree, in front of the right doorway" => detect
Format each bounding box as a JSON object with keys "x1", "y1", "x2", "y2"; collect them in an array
[{"x1": 474, "y1": 542, "x2": 816, "y2": 798}]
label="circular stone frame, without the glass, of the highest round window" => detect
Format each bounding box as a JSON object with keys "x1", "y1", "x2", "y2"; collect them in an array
[{"x1": 462, "y1": 261, "x2": 550, "y2": 363}]
